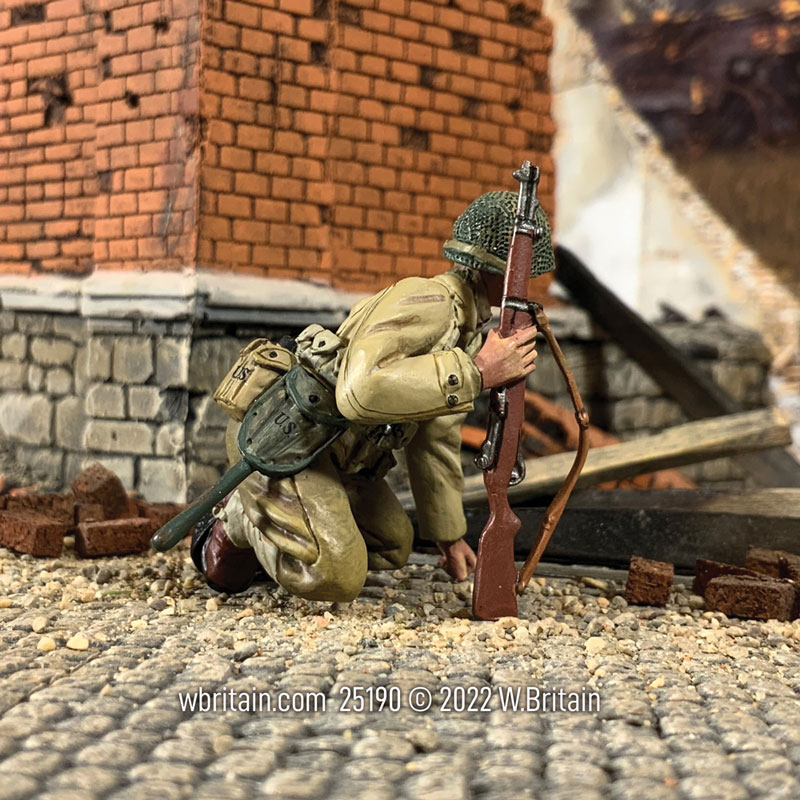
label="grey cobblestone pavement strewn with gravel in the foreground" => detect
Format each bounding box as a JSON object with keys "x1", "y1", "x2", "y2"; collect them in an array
[{"x1": 0, "y1": 548, "x2": 800, "y2": 800}]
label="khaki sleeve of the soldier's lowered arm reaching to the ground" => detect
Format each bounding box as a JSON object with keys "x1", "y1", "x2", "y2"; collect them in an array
[{"x1": 405, "y1": 414, "x2": 467, "y2": 542}]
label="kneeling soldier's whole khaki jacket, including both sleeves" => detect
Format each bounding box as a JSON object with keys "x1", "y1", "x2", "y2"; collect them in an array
[{"x1": 336, "y1": 271, "x2": 491, "y2": 541}]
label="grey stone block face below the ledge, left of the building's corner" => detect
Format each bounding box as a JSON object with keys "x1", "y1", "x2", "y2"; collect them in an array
[{"x1": 0, "y1": 311, "x2": 191, "y2": 500}]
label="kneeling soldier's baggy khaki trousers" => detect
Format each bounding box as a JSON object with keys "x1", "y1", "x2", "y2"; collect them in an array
[{"x1": 215, "y1": 421, "x2": 413, "y2": 602}]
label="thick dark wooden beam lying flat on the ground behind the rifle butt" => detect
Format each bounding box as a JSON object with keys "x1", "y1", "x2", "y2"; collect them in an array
[{"x1": 450, "y1": 489, "x2": 800, "y2": 572}]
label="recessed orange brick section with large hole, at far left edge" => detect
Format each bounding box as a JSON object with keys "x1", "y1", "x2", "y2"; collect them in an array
[{"x1": 0, "y1": 0, "x2": 98, "y2": 272}]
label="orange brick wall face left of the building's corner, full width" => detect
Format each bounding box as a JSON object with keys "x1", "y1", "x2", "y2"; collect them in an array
[{"x1": 0, "y1": 0, "x2": 200, "y2": 273}]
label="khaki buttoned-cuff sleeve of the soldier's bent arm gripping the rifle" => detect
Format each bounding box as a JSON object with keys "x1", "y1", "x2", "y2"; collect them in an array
[{"x1": 336, "y1": 278, "x2": 481, "y2": 424}]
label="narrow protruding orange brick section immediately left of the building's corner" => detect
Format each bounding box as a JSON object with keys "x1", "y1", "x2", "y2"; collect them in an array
[{"x1": 94, "y1": 0, "x2": 202, "y2": 269}]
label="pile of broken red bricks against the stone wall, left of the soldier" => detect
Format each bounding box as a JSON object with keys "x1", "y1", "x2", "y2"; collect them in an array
[{"x1": 0, "y1": 463, "x2": 182, "y2": 558}]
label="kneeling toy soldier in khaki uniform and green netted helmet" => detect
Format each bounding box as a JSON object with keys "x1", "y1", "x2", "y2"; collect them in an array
[{"x1": 180, "y1": 192, "x2": 554, "y2": 601}]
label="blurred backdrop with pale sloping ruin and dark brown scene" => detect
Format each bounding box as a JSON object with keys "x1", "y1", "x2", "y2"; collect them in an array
[{"x1": 549, "y1": 0, "x2": 800, "y2": 328}]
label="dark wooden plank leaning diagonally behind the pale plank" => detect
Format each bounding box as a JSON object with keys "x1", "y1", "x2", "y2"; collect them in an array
[{"x1": 555, "y1": 246, "x2": 800, "y2": 488}]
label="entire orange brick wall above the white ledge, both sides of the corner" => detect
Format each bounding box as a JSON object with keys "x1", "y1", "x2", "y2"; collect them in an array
[{"x1": 0, "y1": 0, "x2": 553, "y2": 289}]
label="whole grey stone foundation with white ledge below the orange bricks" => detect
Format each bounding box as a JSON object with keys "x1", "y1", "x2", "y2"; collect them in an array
[{"x1": 0, "y1": 276, "x2": 769, "y2": 502}]
